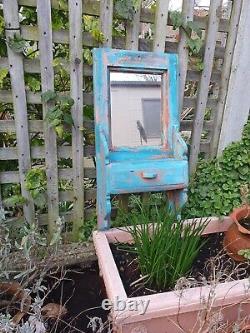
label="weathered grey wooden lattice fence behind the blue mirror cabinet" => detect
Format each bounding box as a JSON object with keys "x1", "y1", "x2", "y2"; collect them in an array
[{"x1": 0, "y1": 0, "x2": 246, "y2": 238}]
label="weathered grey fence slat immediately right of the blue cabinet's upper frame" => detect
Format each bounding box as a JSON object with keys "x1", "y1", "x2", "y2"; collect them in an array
[{"x1": 178, "y1": 0, "x2": 194, "y2": 114}]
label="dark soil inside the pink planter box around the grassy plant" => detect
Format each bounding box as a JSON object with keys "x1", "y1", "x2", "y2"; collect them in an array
[{"x1": 111, "y1": 233, "x2": 250, "y2": 296}]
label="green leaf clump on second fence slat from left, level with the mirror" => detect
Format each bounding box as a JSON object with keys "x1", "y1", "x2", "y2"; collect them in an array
[{"x1": 42, "y1": 90, "x2": 74, "y2": 138}]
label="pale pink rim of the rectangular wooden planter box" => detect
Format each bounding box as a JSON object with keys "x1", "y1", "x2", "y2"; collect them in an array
[{"x1": 93, "y1": 217, "x2": 249, "y2": 325}]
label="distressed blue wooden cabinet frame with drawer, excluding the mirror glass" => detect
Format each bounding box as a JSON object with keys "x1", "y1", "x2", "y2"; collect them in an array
[{"x1": 93, "y1": 48, "x2": 188, "y2": 229}]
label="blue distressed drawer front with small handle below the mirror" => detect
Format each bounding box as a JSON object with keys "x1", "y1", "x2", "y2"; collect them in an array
[{"x1": 108, "y1": 160, "x2": 188, "y2": 194}]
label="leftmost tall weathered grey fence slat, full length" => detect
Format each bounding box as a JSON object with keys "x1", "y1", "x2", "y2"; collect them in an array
[{"x1": 3, "y1": 0, "x2": 35, "y2": 223}]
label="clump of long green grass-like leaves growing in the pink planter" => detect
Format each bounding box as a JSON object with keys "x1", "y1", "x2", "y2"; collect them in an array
[{"x1": 118, "y1": 198, "x2": 207, "y2": 290}]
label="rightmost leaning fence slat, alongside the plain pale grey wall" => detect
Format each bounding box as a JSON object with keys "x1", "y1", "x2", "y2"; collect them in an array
[{"x1": 210, "y1": 0, "x2": 242, "y2": 157}]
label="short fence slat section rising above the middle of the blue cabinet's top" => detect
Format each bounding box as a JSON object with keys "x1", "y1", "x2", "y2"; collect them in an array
[{"x1": 126, "y1": 0, "x2": 142, "y2": 50}]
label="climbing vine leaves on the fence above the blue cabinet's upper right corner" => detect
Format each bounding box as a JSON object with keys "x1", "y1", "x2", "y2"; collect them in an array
[{"x1": 170, "y1": 11, "x2": 204, "y2": 71}]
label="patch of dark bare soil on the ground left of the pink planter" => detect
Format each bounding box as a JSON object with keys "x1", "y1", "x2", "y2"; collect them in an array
[{"x1": 43, "y1": 263, "x2": 108, "y2": 333}]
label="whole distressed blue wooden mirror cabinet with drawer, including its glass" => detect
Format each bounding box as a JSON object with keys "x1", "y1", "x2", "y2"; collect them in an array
[{"x1": 93, "y1": 48, "x2": 188, "y2": 230}]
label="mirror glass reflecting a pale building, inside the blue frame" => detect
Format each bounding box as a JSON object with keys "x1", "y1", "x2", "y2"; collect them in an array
[{"x1": 110, "y1": 72, "x2": 162, "y2": 147}]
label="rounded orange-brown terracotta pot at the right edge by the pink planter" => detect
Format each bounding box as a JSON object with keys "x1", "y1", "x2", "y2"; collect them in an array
[{"x1": 223, "y1": 206, "x2": 250, "y2": 261}]
